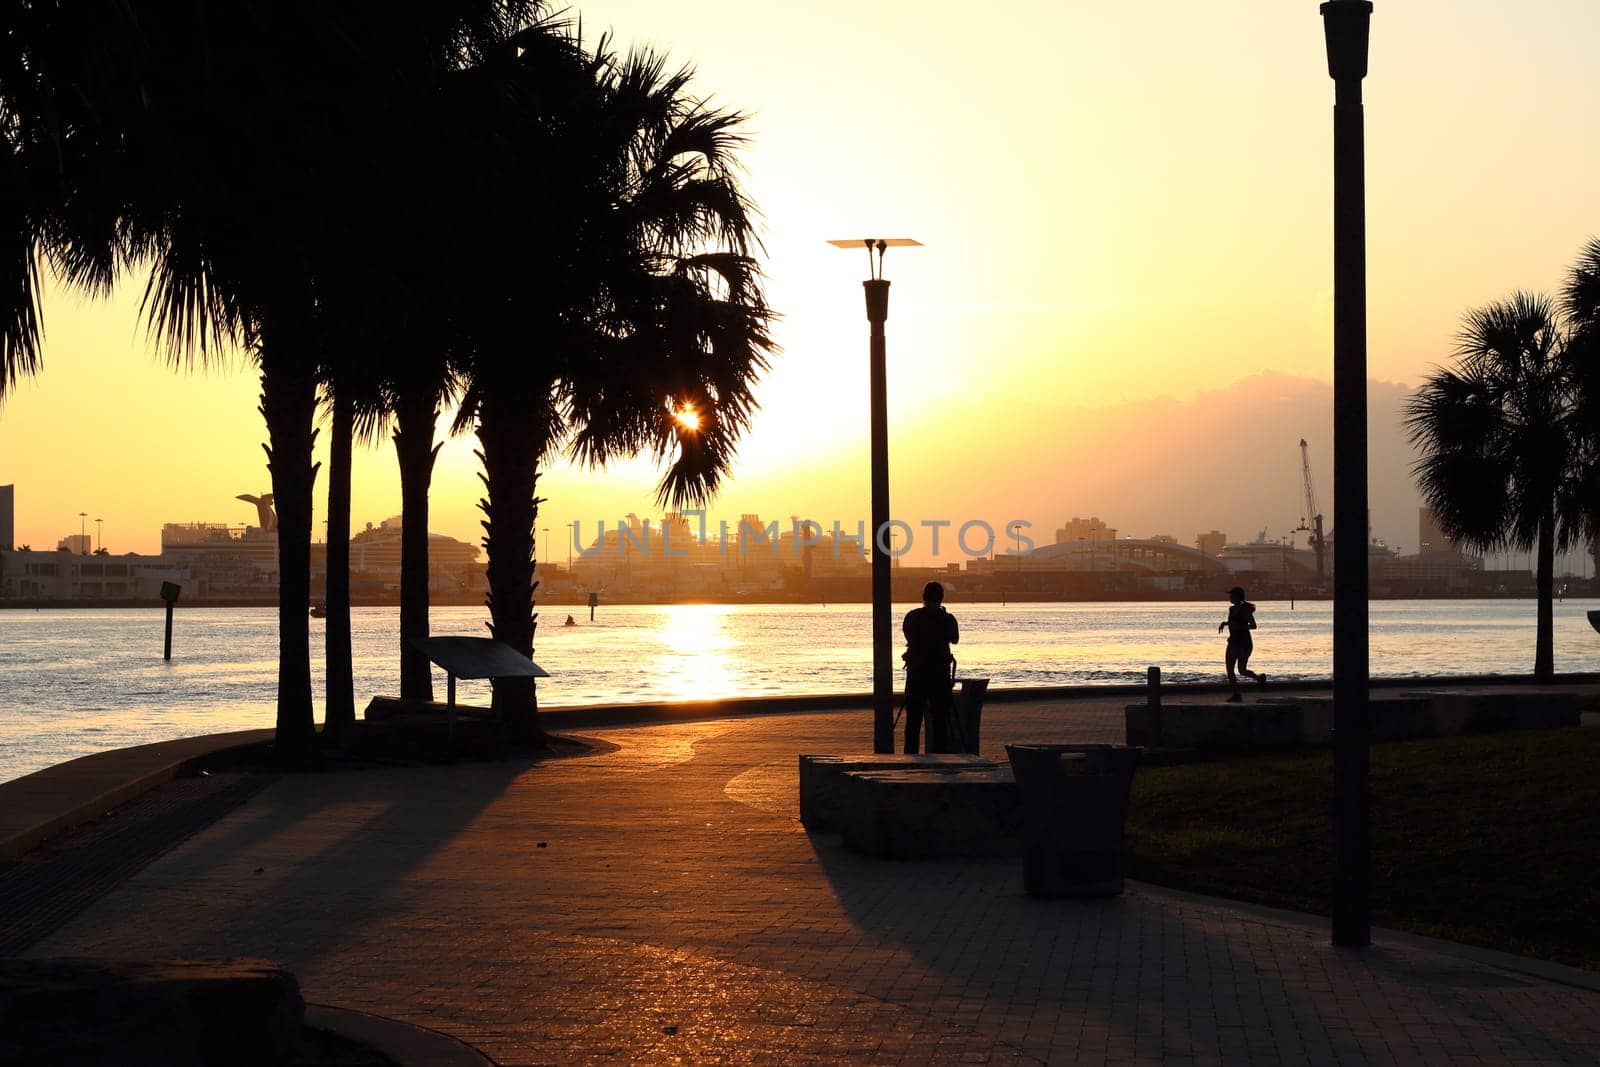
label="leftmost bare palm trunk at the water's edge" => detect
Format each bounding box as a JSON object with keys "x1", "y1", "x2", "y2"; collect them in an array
[{"x1": 261, "y1": 344, "x2": 317, "y2": 763}]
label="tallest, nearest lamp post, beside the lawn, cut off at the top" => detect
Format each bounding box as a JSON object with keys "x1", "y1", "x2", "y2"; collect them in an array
[{"x1": 1322, "y1": 0, "x2": 1373, "y2": 945}]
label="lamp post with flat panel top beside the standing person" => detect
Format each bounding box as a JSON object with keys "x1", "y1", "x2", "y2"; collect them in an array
[{"x1": 829, "y1": 237, "x2": 922, "y2": 752}]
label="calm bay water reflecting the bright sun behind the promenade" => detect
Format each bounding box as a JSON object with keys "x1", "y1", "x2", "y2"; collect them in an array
[{"x1": 0, "y1": 600, "x2": 1600, "y2": 781}]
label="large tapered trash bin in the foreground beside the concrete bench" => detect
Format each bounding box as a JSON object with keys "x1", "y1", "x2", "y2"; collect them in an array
[{"x1": 1006, "y1": 744, "x2": 1142, "y2": 897}]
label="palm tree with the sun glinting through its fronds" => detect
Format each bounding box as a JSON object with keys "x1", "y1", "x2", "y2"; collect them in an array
[{"x1": 458, "y1": 37, "x2": 773, "y2": 741}]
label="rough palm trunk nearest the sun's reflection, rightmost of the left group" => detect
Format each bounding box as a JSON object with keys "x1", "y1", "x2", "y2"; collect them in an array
[{"x1": 478, "y1": 390, "x2": 544, "y2": 745}]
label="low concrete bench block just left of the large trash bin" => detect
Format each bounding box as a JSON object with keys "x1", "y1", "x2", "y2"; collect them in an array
[{"x1": 840, "y1": 766, "x2": 1022, "y2": 859}]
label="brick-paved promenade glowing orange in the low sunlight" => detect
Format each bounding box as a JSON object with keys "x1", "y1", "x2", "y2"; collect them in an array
[{"x1": 15, "y1": 702, "x2": 1600, "y2": 1064}]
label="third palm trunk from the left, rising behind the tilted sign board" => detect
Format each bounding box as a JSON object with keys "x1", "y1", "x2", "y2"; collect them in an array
[{"x1": 395, "y1": 389, "x2": 438, "y2": 701}]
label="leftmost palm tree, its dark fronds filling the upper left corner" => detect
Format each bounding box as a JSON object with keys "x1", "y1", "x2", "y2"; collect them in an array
[{"x1": 0, "y1": 0, "x2": 536, "y2": 757}]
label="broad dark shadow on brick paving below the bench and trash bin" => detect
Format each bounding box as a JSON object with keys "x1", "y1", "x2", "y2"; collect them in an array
[{"x1": 810, "y1": 835, "x2": 1589, "y2": 1062}]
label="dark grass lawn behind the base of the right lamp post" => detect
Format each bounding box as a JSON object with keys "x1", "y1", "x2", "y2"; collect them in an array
[{"x1": 1126, "y1": 728, "x2": 1600, "y2": 969}]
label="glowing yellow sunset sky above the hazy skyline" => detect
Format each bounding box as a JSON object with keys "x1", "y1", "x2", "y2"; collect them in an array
[{"x1": 0, "y1": 0, "x2": 1600, "y2": 557}]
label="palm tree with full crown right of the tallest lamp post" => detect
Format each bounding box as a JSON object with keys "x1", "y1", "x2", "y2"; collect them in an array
[{"x1": 1406, "y1": 293, "x2": 1586, "y2": 681}]
